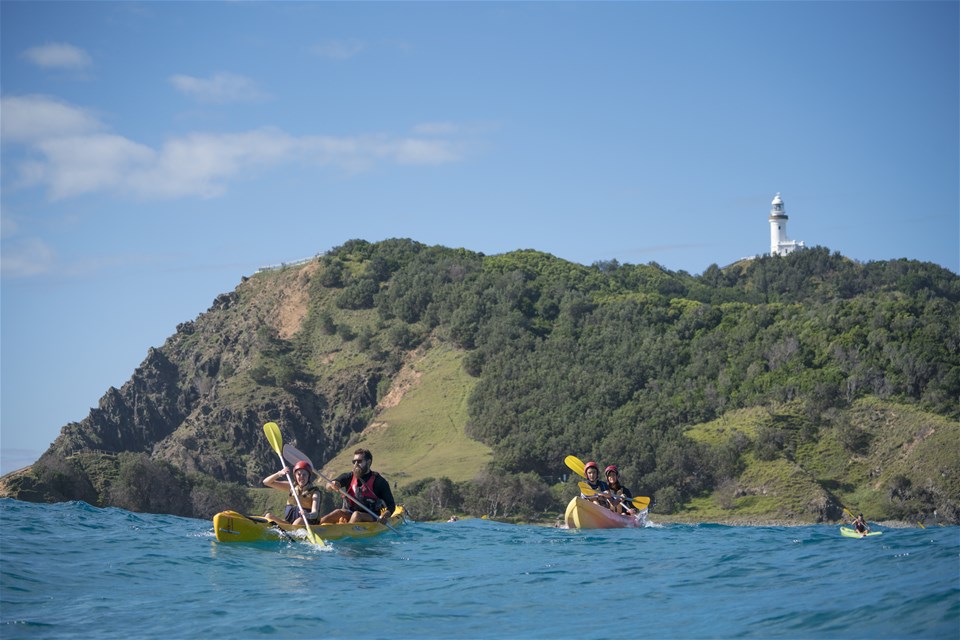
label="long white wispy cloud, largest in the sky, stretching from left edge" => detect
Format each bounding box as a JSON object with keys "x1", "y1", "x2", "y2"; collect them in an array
[{"x1": 0, "y1": 96, "x2": 464, "y2": 200}]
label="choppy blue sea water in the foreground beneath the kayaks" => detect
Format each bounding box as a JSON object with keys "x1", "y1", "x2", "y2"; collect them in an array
[{"x1": 0, "y1": 499, "x2": 960, "y2": 640}]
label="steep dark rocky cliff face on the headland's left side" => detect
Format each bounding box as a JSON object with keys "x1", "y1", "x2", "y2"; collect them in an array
[{"x1": 12, "y1": 262, "x2": 394, "y2": 510}]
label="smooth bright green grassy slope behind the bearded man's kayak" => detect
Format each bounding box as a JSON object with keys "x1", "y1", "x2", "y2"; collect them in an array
[{"x1": 323, "y1": 345, "x2": 492, "y2": 486}]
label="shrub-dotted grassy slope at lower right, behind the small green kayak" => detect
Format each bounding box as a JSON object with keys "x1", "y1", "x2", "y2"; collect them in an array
[{"x1": 683, "y1": 398, "x2": 960, "y2": 521}]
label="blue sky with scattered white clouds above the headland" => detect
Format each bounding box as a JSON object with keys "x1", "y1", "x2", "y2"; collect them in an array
[{"x1": 0, "y1": 1, "x2": 960, "y2": 473}]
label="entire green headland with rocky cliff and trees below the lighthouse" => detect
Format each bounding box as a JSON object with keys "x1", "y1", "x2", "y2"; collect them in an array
[{"x1": 0, "y1": 239, "x2": 960, "y2": 523}]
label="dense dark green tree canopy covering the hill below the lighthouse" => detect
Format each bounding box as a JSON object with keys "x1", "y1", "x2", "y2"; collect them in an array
[{"x1": 350, "y1": 245, "x2": 960, "y2": 516}]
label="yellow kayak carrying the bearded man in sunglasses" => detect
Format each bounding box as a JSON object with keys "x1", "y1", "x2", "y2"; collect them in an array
[{"x1": 213, "y1": 505, "x2": 406, "y2": 542}]
